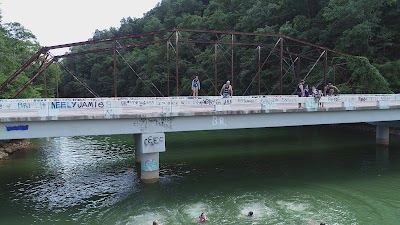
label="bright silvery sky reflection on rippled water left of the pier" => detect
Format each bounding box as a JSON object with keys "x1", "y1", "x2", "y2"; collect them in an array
[{"x1": 10, "y1": 137, "x2": 139, "y2": 223}]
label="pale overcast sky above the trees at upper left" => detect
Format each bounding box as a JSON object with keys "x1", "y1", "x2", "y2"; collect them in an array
[{"x1": 0, "y1": 0, "x2": 161, "y2": 54}]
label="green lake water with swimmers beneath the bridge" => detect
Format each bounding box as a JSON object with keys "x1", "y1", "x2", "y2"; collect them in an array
[{"x1": 0, "y1": 126, "x2": 400, "y2": 225}]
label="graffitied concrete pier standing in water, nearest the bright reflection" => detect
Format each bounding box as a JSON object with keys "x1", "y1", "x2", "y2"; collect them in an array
[{"x1": 134, "y1": 133, "x2": 165, "y2": 183}]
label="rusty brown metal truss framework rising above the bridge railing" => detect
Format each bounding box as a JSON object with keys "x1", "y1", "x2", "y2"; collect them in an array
[{"x1": 0, "y1": 28, "x2": 348, "y2": 98}]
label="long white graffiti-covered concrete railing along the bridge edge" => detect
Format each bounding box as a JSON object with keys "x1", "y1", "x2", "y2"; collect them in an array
[{"x1": 0, "y1": 94, "x2": 400, "y2": 117}]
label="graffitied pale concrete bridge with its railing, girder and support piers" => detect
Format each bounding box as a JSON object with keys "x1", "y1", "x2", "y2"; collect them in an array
[{"x1": 0, "y1": 95, "x2": 400, "y2": 182}]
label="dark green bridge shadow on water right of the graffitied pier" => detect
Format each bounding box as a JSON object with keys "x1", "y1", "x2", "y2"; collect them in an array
[{"x1": 160, "y1": 126, "x2": 399, "y2": 185}]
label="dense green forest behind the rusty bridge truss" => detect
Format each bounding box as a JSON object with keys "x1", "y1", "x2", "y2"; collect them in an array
[{"x1": 0, "y1": 0, "x2": 400, "y2": 97}]
